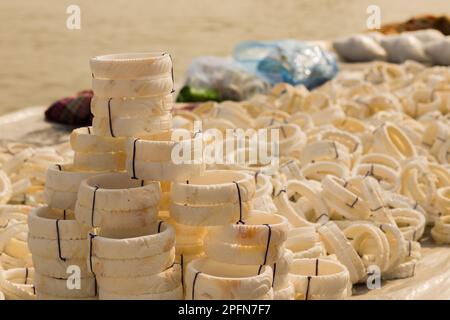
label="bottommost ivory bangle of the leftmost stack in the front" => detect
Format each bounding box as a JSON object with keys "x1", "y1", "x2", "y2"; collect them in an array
[{"x1": 34, "y1": 272, "x2": 97, "y2": 298}]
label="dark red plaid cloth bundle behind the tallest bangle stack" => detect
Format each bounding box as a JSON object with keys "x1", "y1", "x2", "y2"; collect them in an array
[{"x1": 45, "y1": 90, "x2": 93, "y2": 127}]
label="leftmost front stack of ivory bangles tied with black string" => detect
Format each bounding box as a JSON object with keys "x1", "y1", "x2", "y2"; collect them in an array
[{"x1": 28, "y1": 206, "x2": 97, "y2": 299}]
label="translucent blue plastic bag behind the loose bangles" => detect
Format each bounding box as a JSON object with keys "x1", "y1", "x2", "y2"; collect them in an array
[{"x1": 233, "y1": 40, "x2": 339, "y2": 89}]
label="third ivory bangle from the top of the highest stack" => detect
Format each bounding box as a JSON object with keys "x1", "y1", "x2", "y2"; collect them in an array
[{"x1": 91, "y1": 93, "x2": 174, "y2": 118}]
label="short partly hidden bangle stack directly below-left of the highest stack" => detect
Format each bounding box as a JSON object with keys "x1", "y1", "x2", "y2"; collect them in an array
[{"x1": 70, "y1": 127, "x2": 126, "y2": 172}]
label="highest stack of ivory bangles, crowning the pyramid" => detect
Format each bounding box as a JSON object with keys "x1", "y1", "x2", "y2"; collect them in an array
[{"x1": 90, "y1": 52, "x2": 173, "y2": 138}]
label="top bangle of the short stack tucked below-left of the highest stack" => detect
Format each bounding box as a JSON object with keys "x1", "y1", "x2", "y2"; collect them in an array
[{"x1": 70, "y1": 127, "x2": 125, "y2": 153}]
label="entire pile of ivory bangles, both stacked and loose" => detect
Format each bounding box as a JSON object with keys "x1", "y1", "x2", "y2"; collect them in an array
[{"x1": 0, "y1": 52, "x2": 450, "y2": 300}]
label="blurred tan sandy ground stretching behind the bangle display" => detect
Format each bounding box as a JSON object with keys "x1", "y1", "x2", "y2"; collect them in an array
[{"x1": 0, "y1": 0, "x2": 450, "y2": 114}]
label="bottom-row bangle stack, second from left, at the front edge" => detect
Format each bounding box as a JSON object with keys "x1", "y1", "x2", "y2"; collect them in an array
[{"x1": 87, "y1": 221, "x2": 183, "y2": 300}]
